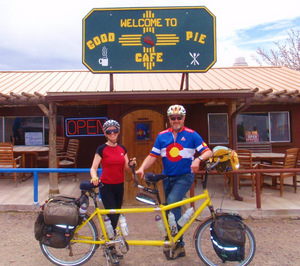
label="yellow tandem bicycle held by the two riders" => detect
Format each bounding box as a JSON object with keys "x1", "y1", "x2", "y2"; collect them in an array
[{"x1": 40, "y1": 161, "x2": 256, "y2": 265}]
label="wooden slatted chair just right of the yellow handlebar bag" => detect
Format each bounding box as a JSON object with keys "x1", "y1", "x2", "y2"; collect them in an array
[{"x1": 237, "y1": 149, "x2": 258, "y2": 196}]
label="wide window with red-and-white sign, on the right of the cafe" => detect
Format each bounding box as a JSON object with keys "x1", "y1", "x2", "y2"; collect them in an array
[{"x1": 237, "y1": 112, "x2": 290, "y2": 142}]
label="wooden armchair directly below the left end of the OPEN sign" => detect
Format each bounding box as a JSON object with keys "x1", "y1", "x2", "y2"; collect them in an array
[{"x1": 57, "y1": 139, "x2": 79, "y2": 180}]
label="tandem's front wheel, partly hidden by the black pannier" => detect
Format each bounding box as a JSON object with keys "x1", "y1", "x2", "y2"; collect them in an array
[{"x1": 195, "y1": 218, "x2": 256, "y2": 266}]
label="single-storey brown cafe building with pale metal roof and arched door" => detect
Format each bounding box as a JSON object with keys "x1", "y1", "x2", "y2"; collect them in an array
[{"x1": 0, "y1": 65, "x2": 300, "y2": 193}]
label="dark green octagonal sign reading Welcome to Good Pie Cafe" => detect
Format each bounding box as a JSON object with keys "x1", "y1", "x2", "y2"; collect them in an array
[{"x1": 82, "y1": 7, "x2": 216, "y2": 73}]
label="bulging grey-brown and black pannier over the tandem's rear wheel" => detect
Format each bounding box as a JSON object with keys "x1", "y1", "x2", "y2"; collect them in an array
[{"x1": 34, "y1": 195, "x2": 79, "y2": 248}]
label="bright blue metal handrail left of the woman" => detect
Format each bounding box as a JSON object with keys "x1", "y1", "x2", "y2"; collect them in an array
[{"x1": 0, "y1": 168, "x2": 102, "y2": 206}]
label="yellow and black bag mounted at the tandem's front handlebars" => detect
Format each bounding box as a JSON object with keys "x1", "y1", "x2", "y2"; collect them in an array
[{"x1": 209, "y1": 146, "x2": 240, "y2": 173}]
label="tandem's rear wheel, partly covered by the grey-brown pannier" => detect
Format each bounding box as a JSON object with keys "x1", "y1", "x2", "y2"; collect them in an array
[{"x1": 40, "y1": 215, "x2": 99, "y2": 266}]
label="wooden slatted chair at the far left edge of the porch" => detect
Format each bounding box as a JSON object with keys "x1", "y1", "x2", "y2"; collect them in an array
[{"x1": 0, "y1": 143, "x2": 22, "y2": 185}]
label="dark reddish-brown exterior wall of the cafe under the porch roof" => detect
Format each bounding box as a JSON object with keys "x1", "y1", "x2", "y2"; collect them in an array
[{"x1": 0, "y1": 101, "x2": 300, "y2": 167}]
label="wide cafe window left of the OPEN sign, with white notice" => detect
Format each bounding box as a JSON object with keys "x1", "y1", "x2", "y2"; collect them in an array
[{"x1": 0, "y1": 116, "x2": 63, "y2": 145}]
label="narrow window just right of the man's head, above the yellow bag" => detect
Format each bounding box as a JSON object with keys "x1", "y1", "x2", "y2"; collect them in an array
[{"x1": 208, "y1": 113, "x2": 229, "y2": 144}]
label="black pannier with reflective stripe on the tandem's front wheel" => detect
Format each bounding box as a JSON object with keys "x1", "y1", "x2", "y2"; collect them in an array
[{"x1": 210, "y1": 214, "x2": 246, "y2": 263}]
